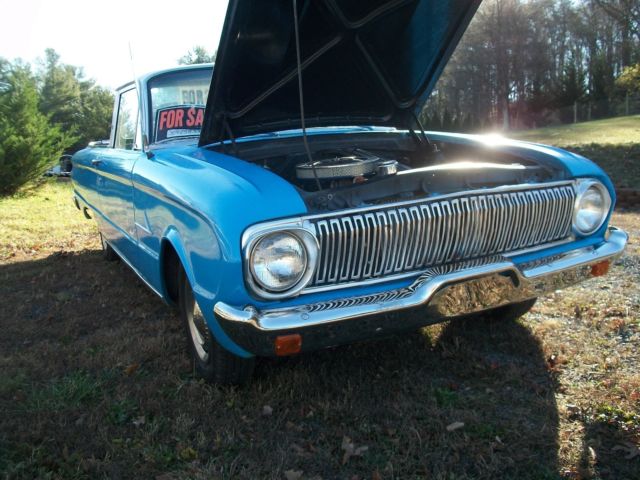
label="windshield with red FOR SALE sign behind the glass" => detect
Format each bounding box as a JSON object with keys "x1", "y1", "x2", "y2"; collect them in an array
[{"x1": 149, "y1": 67, "x2": 213, "y2": 142}]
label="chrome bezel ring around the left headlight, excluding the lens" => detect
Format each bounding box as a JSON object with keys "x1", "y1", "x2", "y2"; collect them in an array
[{"x1": 242, "y1": 225, "x2": 320, "y2": 300}]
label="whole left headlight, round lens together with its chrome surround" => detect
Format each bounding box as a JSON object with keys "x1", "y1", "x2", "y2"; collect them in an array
[{"x1": 247, "y1": 230, "x2": 317, "y2": 298}]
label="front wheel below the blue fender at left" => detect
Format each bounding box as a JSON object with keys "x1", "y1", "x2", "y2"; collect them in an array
[{"x1": 178, "y1": 267, "x2": 255, "y2": 385}]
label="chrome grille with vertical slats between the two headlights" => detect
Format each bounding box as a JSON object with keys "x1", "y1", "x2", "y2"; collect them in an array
[{"x1": 308, "y1": 183, "x2": 575, "y2": 288}]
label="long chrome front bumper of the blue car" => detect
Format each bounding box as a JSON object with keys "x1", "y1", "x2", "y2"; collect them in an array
[{"x1": 214, "y1": 227, "x2": 628, "y2": 356}]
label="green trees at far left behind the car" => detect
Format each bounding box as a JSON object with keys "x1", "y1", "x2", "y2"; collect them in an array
[{"x1": 0, "y1": 49, "x2": 113, "y2": 195}]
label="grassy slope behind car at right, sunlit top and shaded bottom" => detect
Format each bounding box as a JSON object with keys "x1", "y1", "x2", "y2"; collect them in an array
[{"x1": 509, "y1": 115, "x2": 640, "y2": 189}]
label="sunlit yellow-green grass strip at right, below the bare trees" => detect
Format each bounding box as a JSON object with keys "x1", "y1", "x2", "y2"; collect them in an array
[{"x1": 509, "y1": 115, "x2": 640, "y2": 147}]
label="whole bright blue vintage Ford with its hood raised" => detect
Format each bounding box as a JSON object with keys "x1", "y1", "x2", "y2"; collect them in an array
[{"x1": 73, "y1": 0, "x2": 627, "y2": 383}]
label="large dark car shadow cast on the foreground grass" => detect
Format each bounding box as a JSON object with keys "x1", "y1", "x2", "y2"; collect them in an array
[{"x1": 0, "y1": 252, "x2": 559, "y2": 479}]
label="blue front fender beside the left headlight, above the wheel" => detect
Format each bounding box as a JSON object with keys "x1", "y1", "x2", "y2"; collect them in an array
[{"x1": 134, "y1": 147, "x2": 307, "y2": 356}]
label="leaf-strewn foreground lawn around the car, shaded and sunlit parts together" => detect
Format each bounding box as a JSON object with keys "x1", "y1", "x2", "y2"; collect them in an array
[{"x1": 0, "y1": 183, "x2": 640, "y2": 480}]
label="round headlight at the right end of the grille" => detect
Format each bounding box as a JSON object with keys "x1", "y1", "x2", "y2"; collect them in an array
[{"x1": 573, "y1": 180, "x2": 611, "y2": 235}]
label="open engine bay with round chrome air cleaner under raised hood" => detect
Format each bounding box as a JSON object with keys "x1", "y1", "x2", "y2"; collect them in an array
[{"x1": 214, "y1": 135, "x2": 560, "y2": 212}]
